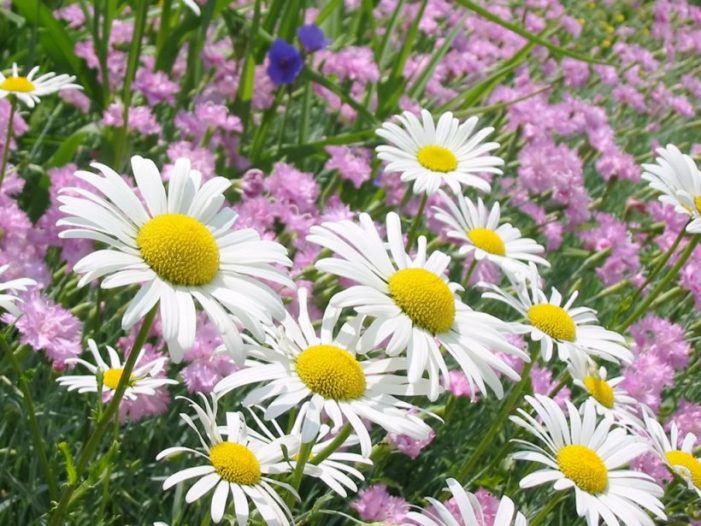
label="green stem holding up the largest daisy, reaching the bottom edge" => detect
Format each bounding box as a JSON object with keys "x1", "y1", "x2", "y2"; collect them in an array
[{"x1": 49, "y1": 307, "x2": 157, "y2": 526}]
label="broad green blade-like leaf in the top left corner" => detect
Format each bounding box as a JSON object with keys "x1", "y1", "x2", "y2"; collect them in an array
[{"x1": 13, "y1": 0, "x2": 102, "y2": 110}]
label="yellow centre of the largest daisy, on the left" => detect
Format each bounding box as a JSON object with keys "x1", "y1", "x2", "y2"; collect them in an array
[{"x1": 136, "y1": 214, "x2": 219, "y2": 287}]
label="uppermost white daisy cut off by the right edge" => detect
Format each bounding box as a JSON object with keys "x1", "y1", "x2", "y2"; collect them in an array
[{"x1": 643, "y1": 144, "x2": 701, "y2": 234}]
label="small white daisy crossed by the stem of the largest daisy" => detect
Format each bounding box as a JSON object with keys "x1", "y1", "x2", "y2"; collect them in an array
[{"x1": 56, "y1": 339, "x2": 178, "y2": 400}]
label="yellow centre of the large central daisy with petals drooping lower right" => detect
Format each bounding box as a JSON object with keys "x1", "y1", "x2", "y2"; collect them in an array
[{"x1": 388, "y1": 268, "x2": 455, "y2": 334}]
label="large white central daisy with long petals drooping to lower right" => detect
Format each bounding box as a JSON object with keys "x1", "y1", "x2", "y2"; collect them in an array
[{"x1": 307, "y1": 212, "x2": 528, "y2": 399}]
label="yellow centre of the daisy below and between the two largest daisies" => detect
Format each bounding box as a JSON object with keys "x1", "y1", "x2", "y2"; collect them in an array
[{"x1": 295, "y1": 345, "x2": 365, "y2": 400}]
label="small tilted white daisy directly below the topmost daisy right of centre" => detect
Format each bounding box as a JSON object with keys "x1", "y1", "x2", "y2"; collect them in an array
[{"x1": 433, "y1": 192, "x2": 550, "y2": 274}]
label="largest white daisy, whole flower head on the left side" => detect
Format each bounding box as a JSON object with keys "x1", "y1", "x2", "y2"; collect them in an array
[{"x1": 58, "y1": 156, "x2": 294, "y2": 364}]
